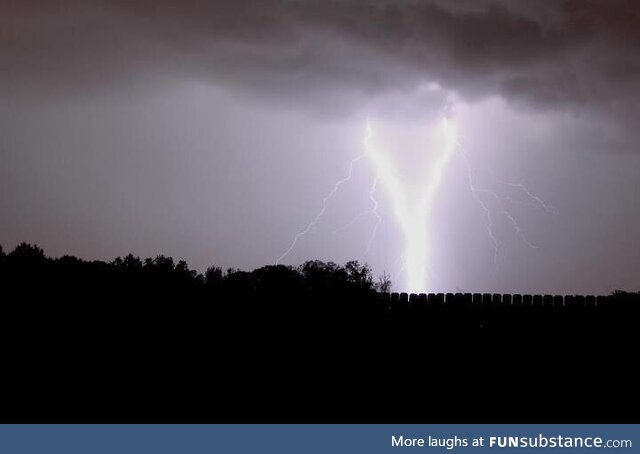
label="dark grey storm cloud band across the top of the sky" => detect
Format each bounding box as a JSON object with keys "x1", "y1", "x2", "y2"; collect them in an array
[{"x1": 0, "y1": 0, "x2": 640, "y2": 114}]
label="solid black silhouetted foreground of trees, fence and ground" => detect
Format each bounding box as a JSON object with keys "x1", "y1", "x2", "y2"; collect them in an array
[{"x1": 0, "y1": 243, "x2": 640, "y2": 422}]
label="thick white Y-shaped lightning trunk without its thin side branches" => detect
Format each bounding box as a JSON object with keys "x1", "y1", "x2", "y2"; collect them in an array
[{"x1": 364, "y1": 118, "x2": 456, "y2": 292}]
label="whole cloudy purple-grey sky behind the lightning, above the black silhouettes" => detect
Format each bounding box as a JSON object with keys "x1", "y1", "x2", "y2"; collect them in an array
[{"x1": 0, "y1": 0, "x2": 640, "y2": 293}]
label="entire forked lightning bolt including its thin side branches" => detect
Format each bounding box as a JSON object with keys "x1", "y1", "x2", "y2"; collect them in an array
[{"x1": 276, "y1": 107, "x2": 552, "y2": 292}]
